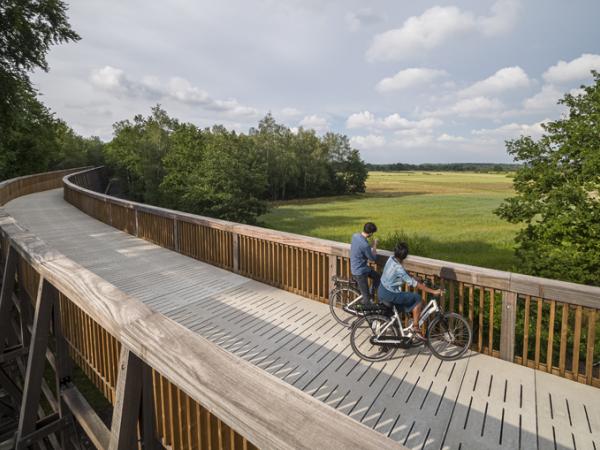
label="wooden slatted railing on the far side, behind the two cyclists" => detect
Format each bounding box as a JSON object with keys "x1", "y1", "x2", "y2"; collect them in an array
[{"x1": 64, "y1": 169, "x2": 600, "y2": 386}]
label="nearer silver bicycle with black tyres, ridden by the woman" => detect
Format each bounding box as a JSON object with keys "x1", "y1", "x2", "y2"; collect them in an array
[{"x1": 350, "y1": 292, "x2": 473, "y2": 361}]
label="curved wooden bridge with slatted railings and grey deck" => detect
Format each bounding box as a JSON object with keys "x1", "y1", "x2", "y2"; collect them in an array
[{"x1": 0, "y1": 169, "x2": 600, "y2": 449}]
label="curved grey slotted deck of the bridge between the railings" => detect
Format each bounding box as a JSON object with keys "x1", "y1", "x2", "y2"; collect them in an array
[{"x1": 5, "y1": 189, "x2": 600, "y2": 450}]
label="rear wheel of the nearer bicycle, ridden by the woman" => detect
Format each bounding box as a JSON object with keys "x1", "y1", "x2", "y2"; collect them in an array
[{"x1": 350, "y1": 315, "x2": 399, "y2": 361}]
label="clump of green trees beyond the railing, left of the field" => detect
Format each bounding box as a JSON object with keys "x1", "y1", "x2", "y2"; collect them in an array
[{"x1": 104, "y1": 106, "x2": 367, "y2": 223}]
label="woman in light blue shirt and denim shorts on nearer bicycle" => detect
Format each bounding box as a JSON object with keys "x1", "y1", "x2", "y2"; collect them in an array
[{"x1": 377, "y1": 242, "x2": 442, "y2": 336}]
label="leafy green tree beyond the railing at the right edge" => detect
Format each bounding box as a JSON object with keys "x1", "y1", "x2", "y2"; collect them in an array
[{"x1": 496, "y1": 72, "x2": 600, "y2": 285}]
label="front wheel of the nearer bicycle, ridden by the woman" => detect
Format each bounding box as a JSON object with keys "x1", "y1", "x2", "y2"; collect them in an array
[{"x1": 426, "y1": 313, "x2": 473, "y2": 361}]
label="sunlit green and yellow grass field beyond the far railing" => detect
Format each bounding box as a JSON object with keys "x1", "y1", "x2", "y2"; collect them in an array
[{"x1": 260, "y1": 172, "x2": 519, "y2": 270}]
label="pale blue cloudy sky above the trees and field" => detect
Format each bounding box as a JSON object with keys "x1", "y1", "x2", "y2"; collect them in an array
[{"x1": 32, "y1": 0, "x2": 600, "y2": 163}]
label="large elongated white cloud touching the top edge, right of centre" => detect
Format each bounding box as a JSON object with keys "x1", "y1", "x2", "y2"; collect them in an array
[{"x1": 367, "y1": 0, "x2": 519, "y2": 61}]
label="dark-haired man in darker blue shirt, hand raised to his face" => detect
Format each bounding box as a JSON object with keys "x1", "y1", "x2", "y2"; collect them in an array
[{"x1": 350, "y1": 222, "x2": 381, "y2": 305}]
